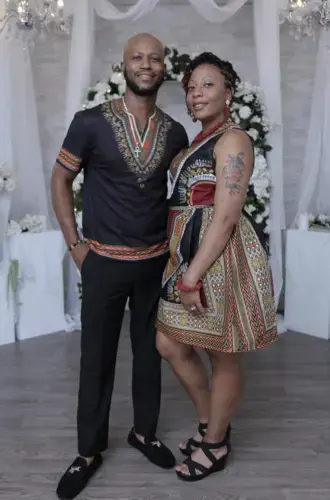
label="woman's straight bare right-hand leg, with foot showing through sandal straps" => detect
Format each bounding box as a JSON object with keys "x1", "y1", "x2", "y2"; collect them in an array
[{"x1": 177, "y1": 351, "x2": 243, "y2": 474}]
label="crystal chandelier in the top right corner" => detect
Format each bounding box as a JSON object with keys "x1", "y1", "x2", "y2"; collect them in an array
[{"x1": 279, "y1": 0, "x2": 330, "y2": 40}]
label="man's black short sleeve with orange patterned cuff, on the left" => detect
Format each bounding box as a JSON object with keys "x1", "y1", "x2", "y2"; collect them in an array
[{"x1": 56, "y1": 111, "x2": 91, "y2": 173}]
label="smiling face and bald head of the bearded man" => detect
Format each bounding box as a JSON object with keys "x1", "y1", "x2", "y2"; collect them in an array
[{"x1": 124, "y1": 37, "x2": 164, "y2": 96}]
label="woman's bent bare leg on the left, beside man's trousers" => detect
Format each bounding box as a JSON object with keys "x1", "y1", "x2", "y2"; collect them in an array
[{"x1": 157, "y1": 332, "x2": 210, "y2": 423}]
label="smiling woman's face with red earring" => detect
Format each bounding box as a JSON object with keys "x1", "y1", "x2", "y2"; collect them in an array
[{"x1": 187, "y1": 64, "x2": 232, "y2": 123}]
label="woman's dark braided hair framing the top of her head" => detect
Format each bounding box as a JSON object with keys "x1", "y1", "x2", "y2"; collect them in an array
[{"x1": 182, "y1": 52, "x2": 241, "y2": 93}]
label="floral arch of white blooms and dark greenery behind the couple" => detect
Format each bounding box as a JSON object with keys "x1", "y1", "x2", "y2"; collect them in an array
[{"x1": 73, "y1": 47, "x2": 272, "y2": 241}]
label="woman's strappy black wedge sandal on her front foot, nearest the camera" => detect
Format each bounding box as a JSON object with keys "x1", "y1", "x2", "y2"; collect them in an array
[{"x1": 176, "y1": 438, "x2": 229, "y2": 483}]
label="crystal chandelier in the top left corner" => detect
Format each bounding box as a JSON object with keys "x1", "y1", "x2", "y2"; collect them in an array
[{"x1": 0, "y1": 0, "x2": 70, "y2": 39}]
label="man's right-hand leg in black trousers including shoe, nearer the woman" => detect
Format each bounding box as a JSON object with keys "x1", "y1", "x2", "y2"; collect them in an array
[{"x1": 129, "y1": 256, "x2": 175, "y2": 468}]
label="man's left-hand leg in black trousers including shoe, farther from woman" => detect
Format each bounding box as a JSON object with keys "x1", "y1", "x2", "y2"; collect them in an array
[{"x1": 57, "y1": 251, "x2": 131, "y2": 499}]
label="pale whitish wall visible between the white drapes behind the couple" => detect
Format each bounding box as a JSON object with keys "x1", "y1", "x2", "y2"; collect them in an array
[{"x1": 33, "y1": 5, "x2": 317, "y2": 224}]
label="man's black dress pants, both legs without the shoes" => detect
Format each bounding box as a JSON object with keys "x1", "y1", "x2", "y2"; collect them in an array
[{"x1": 77, "y1": 250, "x2": 167, "y2": 457}]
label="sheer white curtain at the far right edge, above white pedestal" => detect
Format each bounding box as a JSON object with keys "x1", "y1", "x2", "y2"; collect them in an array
[{"x1": 293, "y1": 29, "x2": 330, "y2": 221}]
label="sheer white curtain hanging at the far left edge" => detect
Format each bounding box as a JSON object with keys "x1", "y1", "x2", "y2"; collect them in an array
[{"x1": 0, "y1": 29, "x2": 48, "y2": 258}]
